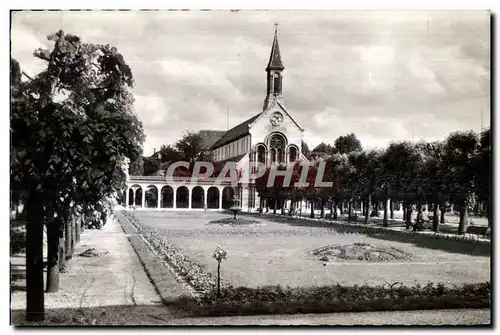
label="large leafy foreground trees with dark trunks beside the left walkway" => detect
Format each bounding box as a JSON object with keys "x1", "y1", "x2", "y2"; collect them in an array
[{"x1": 10, "y1": 31, "x2": 144, "y2": 321}]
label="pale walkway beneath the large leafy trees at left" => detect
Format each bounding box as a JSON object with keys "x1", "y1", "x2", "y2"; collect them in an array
[{"x1": 11, "y1": 219, "x2": 160, "y2": 310}]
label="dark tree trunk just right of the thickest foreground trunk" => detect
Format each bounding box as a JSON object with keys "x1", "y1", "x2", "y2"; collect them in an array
[{"x1": 46, "y1": 220, "x2": 59, "y2": 293}]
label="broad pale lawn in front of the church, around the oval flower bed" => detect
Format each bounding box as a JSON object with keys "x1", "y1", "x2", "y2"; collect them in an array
[{"x1": 135, "y1": 211, "x2": 490, "y2": 287}]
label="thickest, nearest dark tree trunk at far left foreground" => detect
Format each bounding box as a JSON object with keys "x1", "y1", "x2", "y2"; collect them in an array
[{"x1": 26, "y1": 194, "x2": 45, "y2": 321}]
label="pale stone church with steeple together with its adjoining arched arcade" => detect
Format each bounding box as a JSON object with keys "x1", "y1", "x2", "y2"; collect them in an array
[{"x1": 126, "y1": 30, "x2": 306, "y2": 211}]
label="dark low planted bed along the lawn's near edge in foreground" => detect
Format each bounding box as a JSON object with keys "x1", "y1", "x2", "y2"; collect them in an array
[{"x1": 168, "y1": 283, "x2": 491, "y2": 316}]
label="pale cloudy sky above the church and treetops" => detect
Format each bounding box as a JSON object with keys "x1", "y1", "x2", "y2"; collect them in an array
[{"x1": 11, "y1": 11, "x2": 490, "y2": 154}]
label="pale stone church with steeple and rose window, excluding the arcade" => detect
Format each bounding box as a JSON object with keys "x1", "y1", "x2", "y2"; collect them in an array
[{"x1": 211, "y1": 30, "x2": 306, "y2": 209}]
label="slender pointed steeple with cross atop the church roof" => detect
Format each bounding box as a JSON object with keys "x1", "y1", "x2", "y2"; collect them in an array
[{"x1": 264, "y1": 23, "x2": 285, "y2": 110}]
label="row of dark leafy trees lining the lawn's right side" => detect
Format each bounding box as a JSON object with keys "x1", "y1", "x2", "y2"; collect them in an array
[{"x1": 256, "y1": 130, "x2": 491, "y2": 234}]
